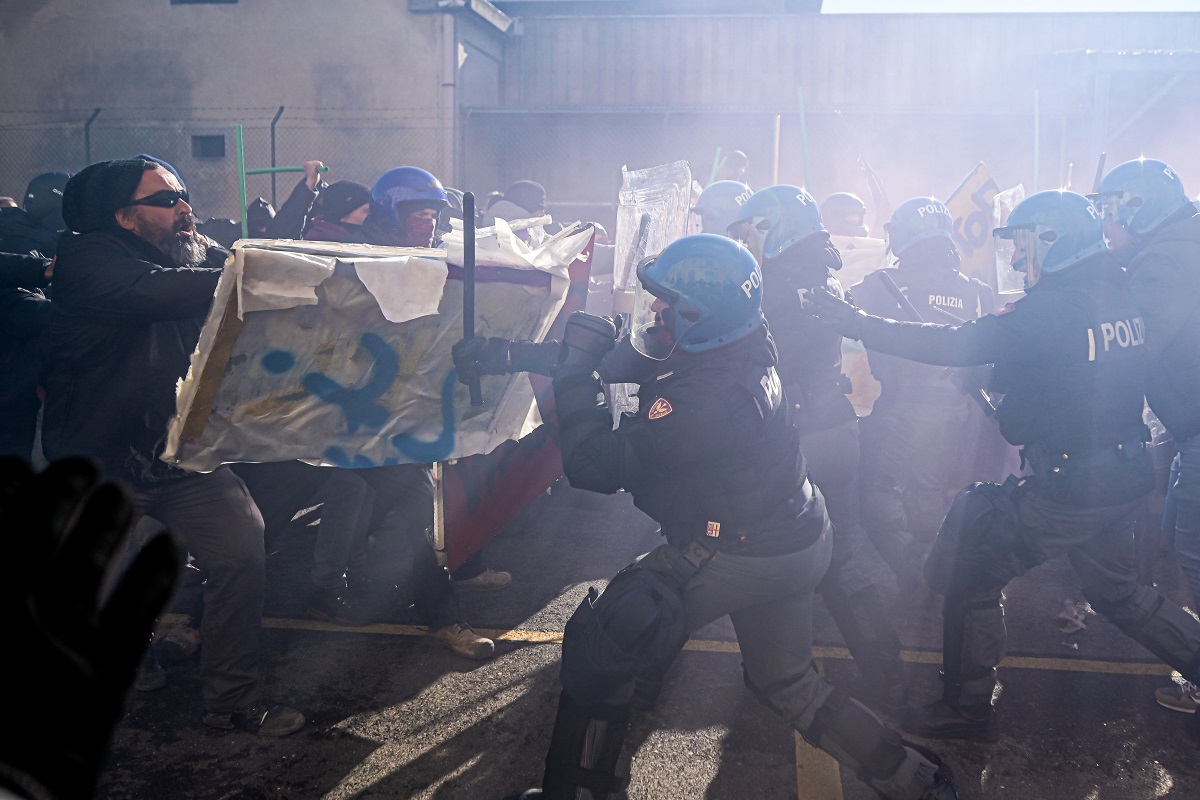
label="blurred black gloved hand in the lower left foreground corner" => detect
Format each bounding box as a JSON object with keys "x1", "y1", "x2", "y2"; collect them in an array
[{"x1": 0, "y1": 458, "x2": 182, "y2": 798}]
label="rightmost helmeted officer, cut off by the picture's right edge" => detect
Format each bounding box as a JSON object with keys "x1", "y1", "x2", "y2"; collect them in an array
[{"x1": 1093, "y1": 158, "x2": 1200, "y2": 714}]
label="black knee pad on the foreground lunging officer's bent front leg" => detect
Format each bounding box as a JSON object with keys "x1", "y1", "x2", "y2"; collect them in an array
[{"x1": 559, "y1": 566, "x2": 688, "y2": 705}]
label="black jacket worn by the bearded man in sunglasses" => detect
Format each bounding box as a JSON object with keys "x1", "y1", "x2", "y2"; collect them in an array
[{"x1": 42, "y1": 225, "x2": 227, "y2": 483}]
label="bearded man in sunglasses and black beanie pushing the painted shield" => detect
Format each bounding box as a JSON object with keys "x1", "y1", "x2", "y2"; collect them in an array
[{"x1": 43, "y1": 158, "x2": 305, "y2": 736}]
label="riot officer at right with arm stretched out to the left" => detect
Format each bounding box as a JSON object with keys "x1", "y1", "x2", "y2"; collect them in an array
[{"x1": 814, "y1": 191, "x2": 1200, "y2": 741}]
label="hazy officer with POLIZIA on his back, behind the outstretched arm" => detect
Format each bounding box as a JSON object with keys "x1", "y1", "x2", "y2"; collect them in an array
[{"x1": 851, "y1": 197, "x2": 994, "y2": 595}]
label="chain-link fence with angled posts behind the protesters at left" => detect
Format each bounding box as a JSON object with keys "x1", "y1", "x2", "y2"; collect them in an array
[{"x1": 0, "y1": 109, "x2": 452, "y2": 218}]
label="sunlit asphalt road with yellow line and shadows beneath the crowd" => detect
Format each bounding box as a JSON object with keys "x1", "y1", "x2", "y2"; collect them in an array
[{"x1": 96, "y1": 485, "x2": 1200, "y2": 800}]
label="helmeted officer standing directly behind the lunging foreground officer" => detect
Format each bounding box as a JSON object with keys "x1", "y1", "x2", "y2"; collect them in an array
[{"x1": 742, "y1": 185, "x2": 906, "y2": 711}]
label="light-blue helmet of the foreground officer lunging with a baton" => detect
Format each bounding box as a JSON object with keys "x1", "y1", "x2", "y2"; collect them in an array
[{"x1": 631, "y1": 234, "x2": 766, "y2": 360}]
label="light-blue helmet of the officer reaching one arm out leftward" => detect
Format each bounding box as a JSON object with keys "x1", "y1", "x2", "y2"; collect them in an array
[{"x1": 992, "y1": 190, "x2": 1108, "y2": 289}]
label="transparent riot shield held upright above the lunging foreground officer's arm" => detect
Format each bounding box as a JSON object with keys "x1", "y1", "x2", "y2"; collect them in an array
[{"x1": 608, "y1": 161, "x2": 692, "y2": 425}]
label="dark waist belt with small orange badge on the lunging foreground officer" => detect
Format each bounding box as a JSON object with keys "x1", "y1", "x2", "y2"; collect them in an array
[{"x1": 662, "y1": 477, "x2": 822, "y2": 570}]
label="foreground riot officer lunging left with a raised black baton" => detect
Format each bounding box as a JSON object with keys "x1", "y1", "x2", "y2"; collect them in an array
[{"x1": 455, "y1": 234, "x2": 958, "y2": 800}]
